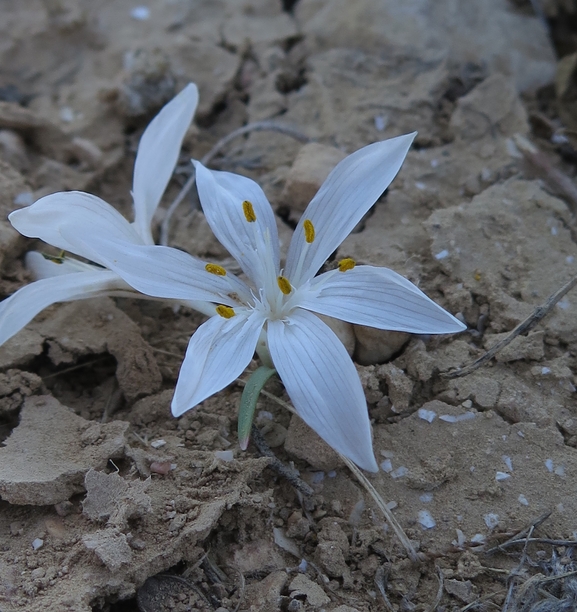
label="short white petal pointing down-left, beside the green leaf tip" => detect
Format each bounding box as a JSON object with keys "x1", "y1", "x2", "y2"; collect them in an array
[{"x1": 172, "y1": 309, "x2": 264, "y2": 416}]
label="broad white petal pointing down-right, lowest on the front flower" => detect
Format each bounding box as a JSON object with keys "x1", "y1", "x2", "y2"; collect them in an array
[{"x1": 267, "y1": 309, "x2": 378, "y2": 472}]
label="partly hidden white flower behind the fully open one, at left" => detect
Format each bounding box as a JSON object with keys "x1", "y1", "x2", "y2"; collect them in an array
[{"x1": 0, "y1": 83, "x2": 198, "y2": 344}]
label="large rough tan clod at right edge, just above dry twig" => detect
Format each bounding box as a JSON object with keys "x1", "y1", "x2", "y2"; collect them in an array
[{"x1": 426, "y1": 179, "x2": 577, "y2": 343}]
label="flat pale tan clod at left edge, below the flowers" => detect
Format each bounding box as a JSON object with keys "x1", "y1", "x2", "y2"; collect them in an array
[{"x1": 0, "y1": 395, "x2": 128, "y2": 506}]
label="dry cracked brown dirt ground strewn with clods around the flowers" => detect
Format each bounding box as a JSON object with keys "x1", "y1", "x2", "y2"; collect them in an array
[{"x1": 0, "y1": 0, "x2": 577, "y2": 612}]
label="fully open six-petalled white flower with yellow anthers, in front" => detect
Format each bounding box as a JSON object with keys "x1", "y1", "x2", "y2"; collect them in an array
[{"x1": 31, "y1": 134, "x2": 464, "y2": 471}]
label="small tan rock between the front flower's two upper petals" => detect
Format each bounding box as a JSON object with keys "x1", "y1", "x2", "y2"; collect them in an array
[{"x1": 281, "y1": 142, "x2": 346, "y2": 213}]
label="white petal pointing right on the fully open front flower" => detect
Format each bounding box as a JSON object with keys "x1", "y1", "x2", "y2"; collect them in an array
[{"x1": 299, "y1": 266, "x2": 466, "y2": 334}]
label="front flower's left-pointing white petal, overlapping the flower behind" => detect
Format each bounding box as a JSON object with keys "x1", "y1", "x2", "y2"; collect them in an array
[{"x1": 74, "y1": 238, "x2": 250, "y2": 314}]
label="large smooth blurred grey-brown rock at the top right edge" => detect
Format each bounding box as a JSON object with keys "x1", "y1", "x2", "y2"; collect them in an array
[{"x1": 295, "y1": 0, "x2": 555, "y2": 91}]
